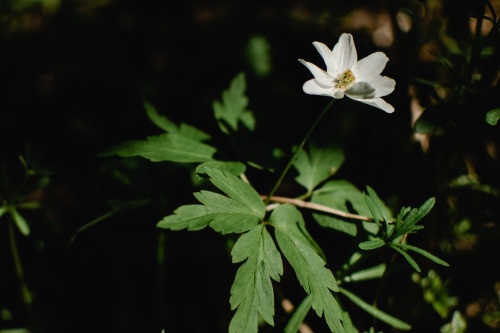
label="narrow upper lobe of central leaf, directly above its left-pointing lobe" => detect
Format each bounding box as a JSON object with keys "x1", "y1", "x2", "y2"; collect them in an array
[{"x1": 205, "y1": 168, "x2": 266, "y2": 219}]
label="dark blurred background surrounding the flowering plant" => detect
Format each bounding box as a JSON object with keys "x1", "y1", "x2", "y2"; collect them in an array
[{"x1": 0, "y1": 0, "x2": 500, "y2": 333}]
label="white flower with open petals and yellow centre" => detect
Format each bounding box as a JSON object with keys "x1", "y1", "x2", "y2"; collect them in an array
[{"x1": 299, "y1": 33, "x2": 396, "y2": 113}]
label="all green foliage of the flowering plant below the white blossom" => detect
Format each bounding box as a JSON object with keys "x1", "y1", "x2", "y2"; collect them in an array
[{"x1": 106, "y1": 73, "x2": 454, "y2": 333}]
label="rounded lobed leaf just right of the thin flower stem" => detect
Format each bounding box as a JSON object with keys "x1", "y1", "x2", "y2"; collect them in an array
[{"x1": 293, "y1": 146, "x2": 344, "y2": 192}]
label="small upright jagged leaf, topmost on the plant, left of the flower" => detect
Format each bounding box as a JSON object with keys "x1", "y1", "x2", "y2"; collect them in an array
[{"x1": 213, "y1": 73, "x2": 255, "y2": 133}]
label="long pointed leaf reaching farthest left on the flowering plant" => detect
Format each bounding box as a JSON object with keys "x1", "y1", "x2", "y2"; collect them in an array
[{"x1": 99, "y1": 133, "x2": 217, "y2": 163}]
